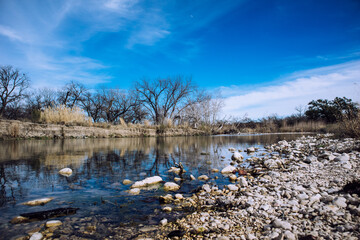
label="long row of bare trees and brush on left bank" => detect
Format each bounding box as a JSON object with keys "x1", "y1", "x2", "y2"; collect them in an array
[{"x1": 0, "y1": 66, "x2": 222, "y2": 126}]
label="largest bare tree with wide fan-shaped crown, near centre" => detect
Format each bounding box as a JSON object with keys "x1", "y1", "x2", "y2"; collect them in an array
[{"x1": 135, "y1": 76, "x2": 196, "y2": 124}]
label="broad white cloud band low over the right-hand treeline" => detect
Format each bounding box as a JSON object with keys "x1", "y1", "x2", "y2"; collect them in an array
[{"x1": 221, "y1": 61, "x2": 360, "y2": 119}]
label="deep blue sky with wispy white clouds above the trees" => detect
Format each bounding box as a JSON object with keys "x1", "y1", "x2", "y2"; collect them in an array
[{"x1": 0, "y1": 0, "x2": 360, "y2": 119}]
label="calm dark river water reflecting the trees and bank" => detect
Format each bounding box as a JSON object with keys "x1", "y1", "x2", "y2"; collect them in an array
[{"x1": 0, "y1": 135, "x2": 306, "y2": 239}]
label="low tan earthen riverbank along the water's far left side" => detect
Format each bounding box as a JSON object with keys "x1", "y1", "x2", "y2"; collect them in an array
[{"x1": 0, "y1": 120, "x2": 205, "y2": 139}]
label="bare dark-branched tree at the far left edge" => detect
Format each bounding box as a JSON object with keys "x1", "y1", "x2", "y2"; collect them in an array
[{"x1": 0, "y1": 66, "x2": 30, "y2": 116}]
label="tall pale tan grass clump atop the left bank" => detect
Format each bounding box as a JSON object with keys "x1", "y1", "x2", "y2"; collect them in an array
[{"x1": 40, "y1": 105, "x2": 92, "y2": 126}]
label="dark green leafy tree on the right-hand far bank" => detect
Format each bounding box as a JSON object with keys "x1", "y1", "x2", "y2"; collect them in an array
[{"x1": 305, "y1": 97, "x2": 359, "y2": 123}]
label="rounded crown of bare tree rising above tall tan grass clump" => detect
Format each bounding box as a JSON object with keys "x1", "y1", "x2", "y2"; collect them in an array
[{"x1": 58, "y1": 81, "x2": 88, "y2": 108}]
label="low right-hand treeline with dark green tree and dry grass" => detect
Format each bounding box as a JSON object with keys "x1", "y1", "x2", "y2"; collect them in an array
[{"x1": 221, "y1": 97, "x2": 360, "y2": 137}]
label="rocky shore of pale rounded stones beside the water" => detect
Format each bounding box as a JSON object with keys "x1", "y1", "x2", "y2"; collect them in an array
[{"x1": 14, "y1": 135, "x2": 360, "y2": 240}]
